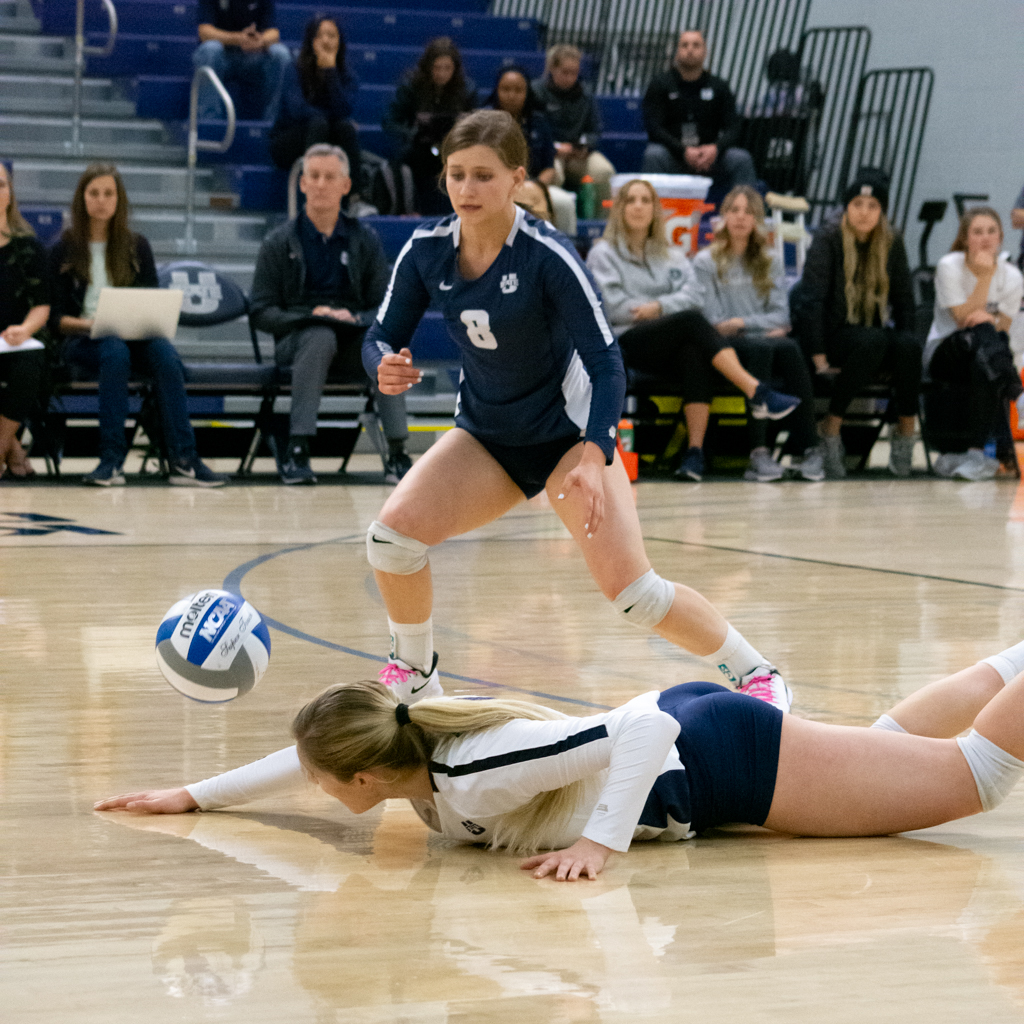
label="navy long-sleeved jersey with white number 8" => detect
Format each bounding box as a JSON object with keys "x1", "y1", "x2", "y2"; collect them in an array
[{"x1": 362, "y1": 203, "x2": 626, "y2": 462}]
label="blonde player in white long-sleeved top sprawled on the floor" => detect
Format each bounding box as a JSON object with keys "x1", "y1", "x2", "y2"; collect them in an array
[{"x1": 95, "y1": 630, "x2": 1024, "y2": 880}]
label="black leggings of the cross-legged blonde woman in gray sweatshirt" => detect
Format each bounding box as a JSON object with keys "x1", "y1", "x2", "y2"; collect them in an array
[{"x1": 618, "y1": 309, "x2": 730, "y2": 406}]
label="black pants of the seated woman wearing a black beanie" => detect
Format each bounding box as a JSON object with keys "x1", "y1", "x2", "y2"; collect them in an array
[{"x1": 826, "y1": 325, "x2": 922, "y2": 416}]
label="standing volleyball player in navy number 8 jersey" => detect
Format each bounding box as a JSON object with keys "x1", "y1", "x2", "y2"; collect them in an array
[{"x1": 362, "y1": 111, "x2": 792, "y2": 711}]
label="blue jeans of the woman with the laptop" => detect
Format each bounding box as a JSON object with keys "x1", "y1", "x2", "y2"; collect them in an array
[{"x1": 63, "y1": 335, "x2": 196, "y2": 466}]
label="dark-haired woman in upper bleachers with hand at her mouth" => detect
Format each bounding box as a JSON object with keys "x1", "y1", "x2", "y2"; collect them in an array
[{"x1": 270, "y1": 17, "x2": 361, "y2": 188}]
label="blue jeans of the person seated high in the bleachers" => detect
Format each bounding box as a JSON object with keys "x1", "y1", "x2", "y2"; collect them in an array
[{"x1": 193, "y1": 40, "x2": 292, "y2": 121}]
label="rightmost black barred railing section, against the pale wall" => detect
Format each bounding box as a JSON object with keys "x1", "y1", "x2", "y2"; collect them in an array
[{"x1": 838, "y1": 68, "x2": 935, "y2": 231}]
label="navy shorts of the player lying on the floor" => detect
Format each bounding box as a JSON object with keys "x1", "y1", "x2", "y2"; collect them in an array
[{"x1": 655, "y1": 683, "x2": 782, "y2": 833}]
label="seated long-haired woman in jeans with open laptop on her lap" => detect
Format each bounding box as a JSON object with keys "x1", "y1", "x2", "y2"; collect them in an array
[{"x1": 50, "y1": 164, "x2": 227, "y2": 487}]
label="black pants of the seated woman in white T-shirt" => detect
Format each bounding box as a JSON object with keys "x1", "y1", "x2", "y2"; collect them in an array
[{"x1": 928, "y1": 324, "x2": 1021, "y2": 447}]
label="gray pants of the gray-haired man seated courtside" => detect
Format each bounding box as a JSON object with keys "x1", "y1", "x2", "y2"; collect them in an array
[{"x1": 273, "y1": 324, "x2": 409, "y2": 441}]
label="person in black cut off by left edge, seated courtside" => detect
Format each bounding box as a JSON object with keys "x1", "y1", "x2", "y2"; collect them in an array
[{"x1": 0, "y1": 164, "x2": 50, "y2": 479}]
